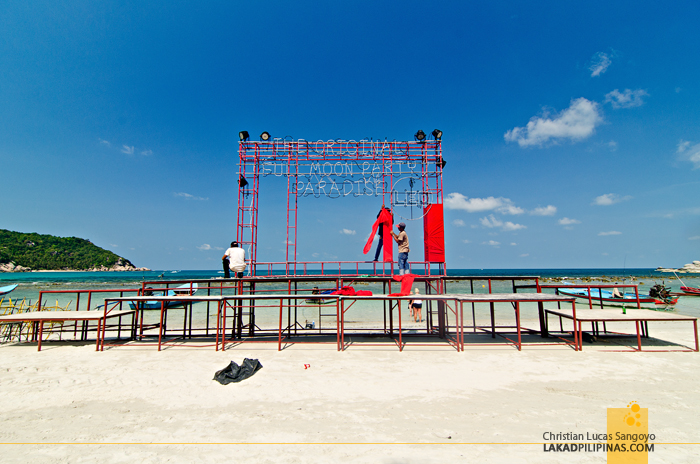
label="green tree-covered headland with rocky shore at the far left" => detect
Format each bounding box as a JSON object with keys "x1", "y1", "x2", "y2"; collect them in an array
[{"x1": 0, "y1": 229, "x2": 150, "y2": 272}]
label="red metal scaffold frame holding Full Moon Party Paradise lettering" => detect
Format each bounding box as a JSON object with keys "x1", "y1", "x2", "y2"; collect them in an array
[{"x1": 236, "y1": 138, "x2": 446, "y2": 275}]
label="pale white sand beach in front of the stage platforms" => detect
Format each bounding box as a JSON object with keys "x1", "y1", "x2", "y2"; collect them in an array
[{"x1": 0, "y1": 323, "x2": 700, "y2": 463}]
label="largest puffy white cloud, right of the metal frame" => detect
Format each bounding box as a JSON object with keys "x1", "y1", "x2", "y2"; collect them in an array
[{"x1": 503, "y1": 97, "x2": 603, "y2": 147}]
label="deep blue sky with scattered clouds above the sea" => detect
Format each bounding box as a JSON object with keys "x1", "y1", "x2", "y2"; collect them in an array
[{"x1": 0, "y1": 0, "x2": 700, "y2": 269}]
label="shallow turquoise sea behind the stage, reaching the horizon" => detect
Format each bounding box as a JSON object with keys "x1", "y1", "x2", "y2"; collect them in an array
[{"x1": 0, "y1": 268, "x2": 700, "y2": 322}]
